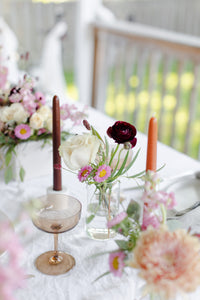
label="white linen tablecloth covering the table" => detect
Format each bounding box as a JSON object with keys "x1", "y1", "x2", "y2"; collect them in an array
[{"x1": 0, "y1": 109, "x2": 200, "y2": 300}]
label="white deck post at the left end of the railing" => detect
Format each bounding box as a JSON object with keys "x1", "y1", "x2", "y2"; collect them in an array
[{"x1": 75, "y1": 0, "x2": 102, "y2": 105}]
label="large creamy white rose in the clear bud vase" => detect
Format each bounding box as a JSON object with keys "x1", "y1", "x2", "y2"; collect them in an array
[{"x1": 59, "y1": 134, "x2": 101, "y2": 170}]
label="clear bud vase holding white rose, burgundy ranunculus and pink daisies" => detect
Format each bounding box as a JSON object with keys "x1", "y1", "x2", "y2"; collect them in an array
[{"x1": 59, "y1": 120, "x2": 143, "y2": 238}]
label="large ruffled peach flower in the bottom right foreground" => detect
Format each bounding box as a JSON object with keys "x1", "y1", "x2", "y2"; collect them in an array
[{"x1": 127, "y1": 226, "x2": 200, "y2": 300}]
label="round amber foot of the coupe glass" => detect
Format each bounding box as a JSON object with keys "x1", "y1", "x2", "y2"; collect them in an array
[{"x1": 35, "y1": 251, "x2": 76, "y2": 275}]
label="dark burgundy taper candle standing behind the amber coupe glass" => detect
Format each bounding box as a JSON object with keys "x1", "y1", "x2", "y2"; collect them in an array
[{"x1": 53, "y1": 96, "x2": 62, "y2": 191}]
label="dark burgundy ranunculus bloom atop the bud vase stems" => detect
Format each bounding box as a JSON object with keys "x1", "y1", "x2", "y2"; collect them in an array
[{"x1": 107, "y1": 121, "x2": 137, "y2": 148}]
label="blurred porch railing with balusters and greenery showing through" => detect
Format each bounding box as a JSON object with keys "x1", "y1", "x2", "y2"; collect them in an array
[{"x1": 92, "y1": 21, "x2": 200, "y2": 158}]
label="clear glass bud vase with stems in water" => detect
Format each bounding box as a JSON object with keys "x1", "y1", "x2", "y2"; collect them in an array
[{"x1": 86, "y1": 182, "x2": 120, "y2": 240}]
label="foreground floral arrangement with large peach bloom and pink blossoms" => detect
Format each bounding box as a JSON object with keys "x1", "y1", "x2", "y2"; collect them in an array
[{"x1": 102, "y1": 171, "x2": 200, "y2": 300}]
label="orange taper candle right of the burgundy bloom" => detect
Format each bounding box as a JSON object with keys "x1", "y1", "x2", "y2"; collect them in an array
[{"x1": 146, "y1": 117, "x2": 158, "y2": 172}]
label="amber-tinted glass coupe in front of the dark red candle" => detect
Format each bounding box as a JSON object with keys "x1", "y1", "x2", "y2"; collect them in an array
[{"x1": 32, "y1": 194, "x2": 82, "y2": 275}]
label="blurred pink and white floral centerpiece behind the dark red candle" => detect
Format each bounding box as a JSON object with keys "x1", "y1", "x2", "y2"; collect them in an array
[{"x1": 0, "y1": 58, "x2": 85, "y2": 183}]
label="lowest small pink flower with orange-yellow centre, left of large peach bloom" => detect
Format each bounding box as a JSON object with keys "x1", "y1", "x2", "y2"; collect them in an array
[{"x1": 109, "y1": 251, "x2": 125, "y2": 277}]
